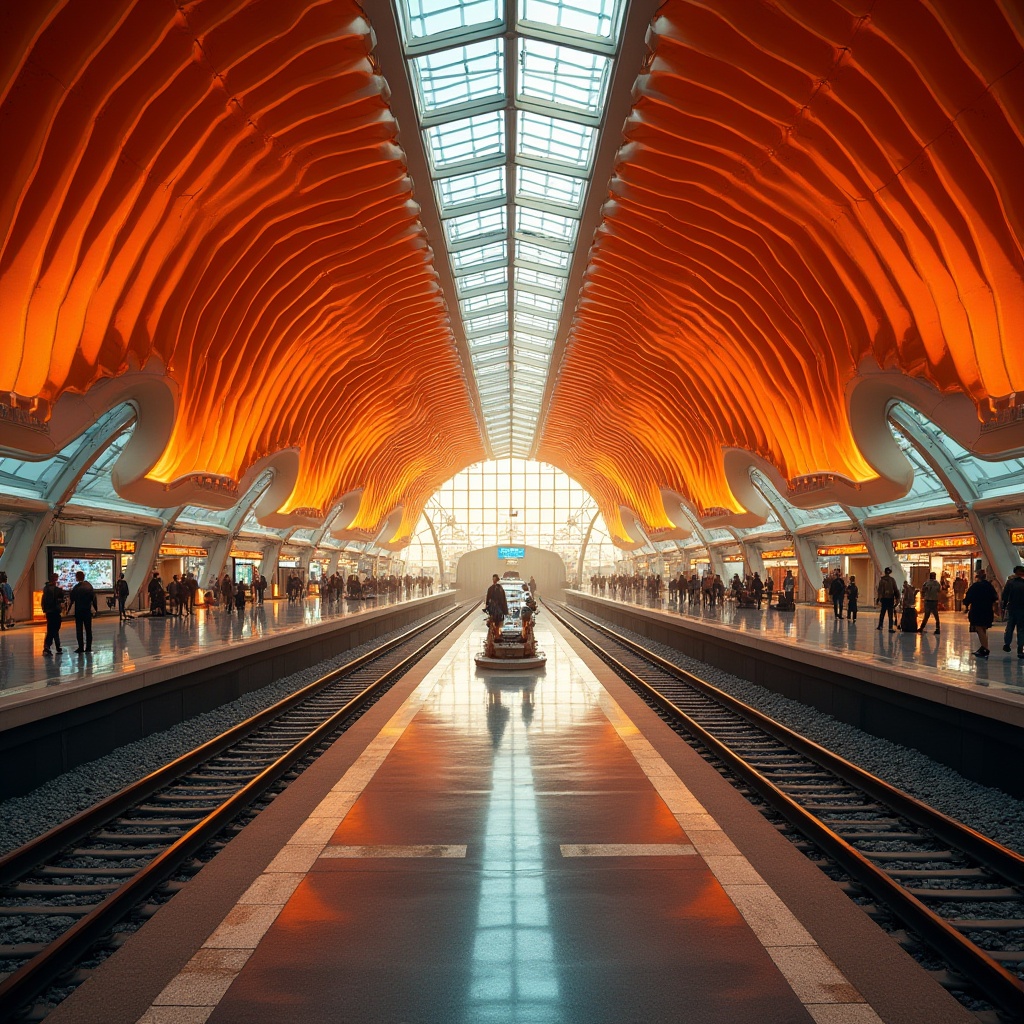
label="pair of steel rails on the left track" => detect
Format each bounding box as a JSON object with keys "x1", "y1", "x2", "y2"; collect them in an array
[{"x1": 0, "y1": 602, "x2": 475, "y2": 1020}]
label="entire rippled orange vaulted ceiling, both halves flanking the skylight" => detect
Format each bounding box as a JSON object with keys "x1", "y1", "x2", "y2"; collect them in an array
[{"x1": 0, "y1": 0, "x2": 1024, "y2": 552}]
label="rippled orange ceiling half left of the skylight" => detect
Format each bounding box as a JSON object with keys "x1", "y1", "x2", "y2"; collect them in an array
[{"x1": 0, "y1": 0, "x2": 482, "y2": 536}]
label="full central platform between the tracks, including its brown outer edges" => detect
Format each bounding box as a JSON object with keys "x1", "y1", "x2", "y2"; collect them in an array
[{"x1": 48, "y1": 612, "x2": 975, "y2": 1024}]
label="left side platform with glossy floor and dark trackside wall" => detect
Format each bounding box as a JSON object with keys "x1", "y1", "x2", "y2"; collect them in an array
[{"x1": 0, "y1": 592, "x2": 456, "y2": 797}]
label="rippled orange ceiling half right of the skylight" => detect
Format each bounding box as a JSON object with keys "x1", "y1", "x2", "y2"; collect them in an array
[{"x1": 538, "y1": 0, "x2": 1024, "y2": 532}]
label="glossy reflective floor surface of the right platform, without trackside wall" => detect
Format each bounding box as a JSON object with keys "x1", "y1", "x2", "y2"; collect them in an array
[{"x1": 598, "y1": 591, "x2": 1024, "y2": 696}]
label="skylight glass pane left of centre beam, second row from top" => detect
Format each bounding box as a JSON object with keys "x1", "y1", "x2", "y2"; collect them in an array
[{"x1": 411, "y1": 37, "x2": 505, "y2": 119}]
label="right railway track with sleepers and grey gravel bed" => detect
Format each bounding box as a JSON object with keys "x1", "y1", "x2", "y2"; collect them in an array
[{"x1": 547, "y1": 605, "x2": 1024, "y2": 1022}]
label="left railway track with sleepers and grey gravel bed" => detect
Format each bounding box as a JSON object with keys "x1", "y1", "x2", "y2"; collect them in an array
[{"x1": 0, "y1": 603, "x2": 475, "y2": 1022}]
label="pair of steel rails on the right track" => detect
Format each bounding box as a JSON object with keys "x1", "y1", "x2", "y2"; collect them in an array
[{"x1": 548, "y1": 605, "x2": 1024, "y2": 1019}]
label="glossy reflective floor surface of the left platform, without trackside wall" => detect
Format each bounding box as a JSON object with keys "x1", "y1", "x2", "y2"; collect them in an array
[{"x1": 0, "y1": 597, "x2": 419, "y2": 706}]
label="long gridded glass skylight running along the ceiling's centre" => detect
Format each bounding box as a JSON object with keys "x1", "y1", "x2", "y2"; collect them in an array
[{"x1": 396, "y1": 0, "x2": 625, "y2": 455}]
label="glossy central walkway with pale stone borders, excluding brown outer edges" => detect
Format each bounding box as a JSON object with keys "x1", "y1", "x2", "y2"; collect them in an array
[{"x1": 123, "y1": 616, "x2": 917, "y2": 1024}]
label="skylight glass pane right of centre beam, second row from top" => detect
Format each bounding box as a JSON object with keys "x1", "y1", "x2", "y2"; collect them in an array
[{"x1": 516, "y1": 37, "x2": 611, "y2": 120}]
